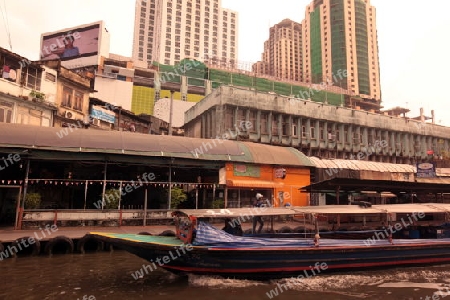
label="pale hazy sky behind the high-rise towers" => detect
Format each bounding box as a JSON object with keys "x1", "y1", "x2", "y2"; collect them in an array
[{"x1": 0, "y1": 0, "x2": 450, "y2": 126}]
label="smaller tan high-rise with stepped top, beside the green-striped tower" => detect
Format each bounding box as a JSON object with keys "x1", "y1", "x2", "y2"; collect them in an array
[{"x1": 252, "y1": 19, "x2": 303, "y2": 81}]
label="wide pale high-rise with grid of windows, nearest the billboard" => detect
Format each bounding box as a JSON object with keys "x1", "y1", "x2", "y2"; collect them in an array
[{"x1": 133, "y1": 0, "x2": 238, "y2": 65}]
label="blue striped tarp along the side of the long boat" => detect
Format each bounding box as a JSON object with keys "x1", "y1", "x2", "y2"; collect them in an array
[{"x1": 192, "y1": 221, "x2": 450, "y2": 248}]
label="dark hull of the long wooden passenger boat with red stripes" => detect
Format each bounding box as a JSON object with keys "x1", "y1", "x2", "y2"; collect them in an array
[{"x1": 89, "y1": 234, "x2": 450, "y2": 279}]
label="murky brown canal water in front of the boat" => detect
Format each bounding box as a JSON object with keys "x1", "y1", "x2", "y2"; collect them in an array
[{"x1": 0, "y1": 251, "x2": 450, "y2": 300}]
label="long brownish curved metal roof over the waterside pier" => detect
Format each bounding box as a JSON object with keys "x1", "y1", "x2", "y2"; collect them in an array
[{"x1": 0, "y1": 123, "x2": 313, "y2": 167}]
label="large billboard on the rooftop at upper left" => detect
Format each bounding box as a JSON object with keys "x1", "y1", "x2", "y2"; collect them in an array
[{"x1": 40, "y1": 22, "x2": 102, "y2": 68}]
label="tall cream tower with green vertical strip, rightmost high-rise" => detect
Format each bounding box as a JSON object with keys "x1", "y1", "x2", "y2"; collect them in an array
[{"x1": 302, "y1": 0, "x2": 381, "y2": 101}]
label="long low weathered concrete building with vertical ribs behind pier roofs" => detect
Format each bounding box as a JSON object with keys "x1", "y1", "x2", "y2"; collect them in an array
[{"x1": 184, "y1": 86, "x2": 450, "y2": 164}]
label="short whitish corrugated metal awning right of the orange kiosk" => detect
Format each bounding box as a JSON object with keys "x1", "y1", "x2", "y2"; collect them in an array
[{"x1": 309, "y1": 157, "x2": 414, "y2": 173}]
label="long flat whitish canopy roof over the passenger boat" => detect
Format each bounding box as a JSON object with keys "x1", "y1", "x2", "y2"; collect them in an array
[{"x1": 178, "y1": 203, "x2": 450, "y2": 218}]
